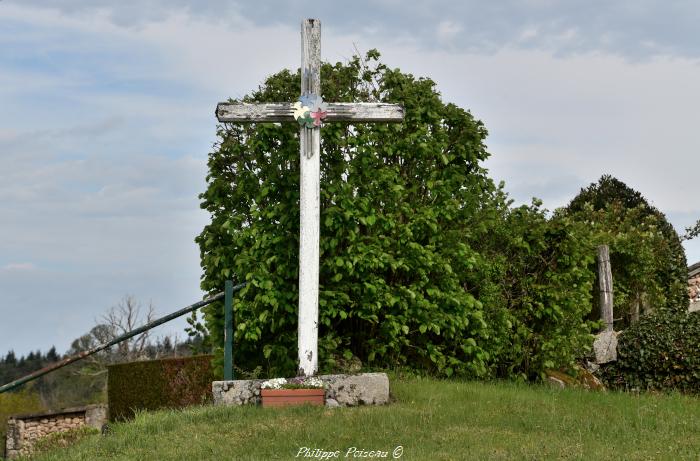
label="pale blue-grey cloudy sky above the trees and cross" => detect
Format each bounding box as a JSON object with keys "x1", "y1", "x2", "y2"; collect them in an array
[{"x1": 0, "y1": 0, "x2": 700, "y2": 354}]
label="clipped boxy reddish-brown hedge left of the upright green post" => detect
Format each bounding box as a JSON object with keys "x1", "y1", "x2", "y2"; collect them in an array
[{"x1": 107, "y1": 355, "x2": 214, "y2": 421}]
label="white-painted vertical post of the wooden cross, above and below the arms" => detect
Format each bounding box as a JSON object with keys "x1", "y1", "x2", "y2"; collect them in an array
[{"x1": 297, "y1": 19, "x2": 321, "y2": 376}]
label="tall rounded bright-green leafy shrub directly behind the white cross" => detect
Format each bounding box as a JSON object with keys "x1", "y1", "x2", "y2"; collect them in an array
[{"x1": 197, "y1": 53, "x2": 495, "y2": 376}]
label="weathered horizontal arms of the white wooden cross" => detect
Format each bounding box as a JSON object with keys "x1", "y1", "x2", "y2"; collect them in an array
[{"x1": 216, "y1": 102, "x2": 403, "y2": 123}]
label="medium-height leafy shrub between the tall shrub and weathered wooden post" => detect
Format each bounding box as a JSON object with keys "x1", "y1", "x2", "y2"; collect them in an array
[{"x1": 477, "y1": 200, "x2": 595, "y2": 379}]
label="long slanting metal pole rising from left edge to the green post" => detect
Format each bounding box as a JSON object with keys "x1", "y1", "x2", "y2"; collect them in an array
[{"x1": 0, "y1": 283, "x2": 246, "y2": 394}]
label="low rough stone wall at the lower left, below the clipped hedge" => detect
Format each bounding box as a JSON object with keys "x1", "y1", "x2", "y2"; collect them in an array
[{"x1": 5, "y1": 405, "x2": 107, "y2": 459}]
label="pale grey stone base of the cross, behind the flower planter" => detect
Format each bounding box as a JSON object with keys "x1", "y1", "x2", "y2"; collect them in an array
[{"x1": 211, "y1": 373, "x2": 389, "y2": 407}]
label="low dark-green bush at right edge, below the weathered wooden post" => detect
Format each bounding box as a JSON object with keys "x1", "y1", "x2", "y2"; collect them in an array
[{"x1": 602, "y1": 311, "x2": 700, "y2": 393}]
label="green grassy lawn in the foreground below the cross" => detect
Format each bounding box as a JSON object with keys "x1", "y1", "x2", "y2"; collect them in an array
[{"x1": 30, "y1": 378, "x2": 700, "y2": 461}]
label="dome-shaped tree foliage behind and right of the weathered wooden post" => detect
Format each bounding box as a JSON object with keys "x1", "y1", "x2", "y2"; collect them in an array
[{"x1": 560, "y1": 175, "x2": 688, "y2": 329}]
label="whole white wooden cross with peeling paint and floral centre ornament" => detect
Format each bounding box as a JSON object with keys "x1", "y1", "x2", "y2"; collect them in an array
[{"x1": 216, "y1": 19, "x2": 403, "y2": 376}]
